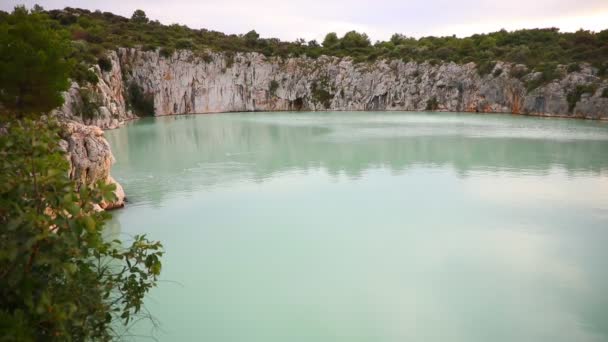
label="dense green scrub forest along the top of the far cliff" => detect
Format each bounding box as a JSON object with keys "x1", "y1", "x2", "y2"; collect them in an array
[{"x1": 0, "y1": 6, "x2": 608, "y2": 85}]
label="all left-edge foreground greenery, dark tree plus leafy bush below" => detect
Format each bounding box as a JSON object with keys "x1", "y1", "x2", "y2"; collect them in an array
[{"x1": 0, "y1": 8, "x2": 163, "y2": 342}]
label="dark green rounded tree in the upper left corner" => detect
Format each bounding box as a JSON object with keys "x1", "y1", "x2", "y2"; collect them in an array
[{"x1": 0, "y1": 7, "x2": 70, "y2": 117}]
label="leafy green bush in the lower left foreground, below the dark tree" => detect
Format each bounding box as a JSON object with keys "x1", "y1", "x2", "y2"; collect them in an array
[{"x1": 0, "y1": 120, "x2": 163, "y2": 341}]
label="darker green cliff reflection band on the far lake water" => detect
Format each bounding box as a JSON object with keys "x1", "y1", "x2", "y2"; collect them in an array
[{"x1": 107, "y1": 113, "x2": 608, "y2": 207}]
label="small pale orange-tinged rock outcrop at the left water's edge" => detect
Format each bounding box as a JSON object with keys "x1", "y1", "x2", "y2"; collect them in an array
[{"x1": 61, "y1": 122, "x2": 125, "y2": 210}]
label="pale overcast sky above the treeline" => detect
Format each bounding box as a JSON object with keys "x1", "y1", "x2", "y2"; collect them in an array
[{"x1": 0, "y1": 0, "x2": 608, "y2": 40}]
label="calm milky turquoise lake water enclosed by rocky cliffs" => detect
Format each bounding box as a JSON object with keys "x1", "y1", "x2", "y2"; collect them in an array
[{"x1": 106, "y1": 113, "x2": 608, "y2": 342}]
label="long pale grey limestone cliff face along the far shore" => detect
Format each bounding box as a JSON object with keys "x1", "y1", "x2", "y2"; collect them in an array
[{"x1": 116, "y1": 49, "x2": 608, "y2": 119}]
